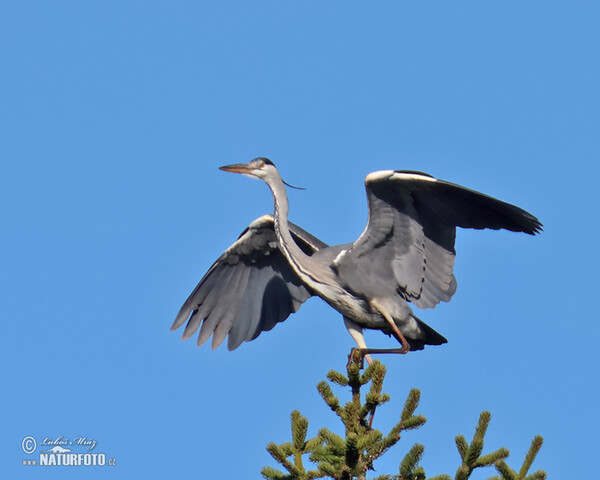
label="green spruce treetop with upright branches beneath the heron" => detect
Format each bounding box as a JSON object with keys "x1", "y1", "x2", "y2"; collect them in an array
[{"x1": 261, "y1": 349, "x2": 546, "y2": 480}]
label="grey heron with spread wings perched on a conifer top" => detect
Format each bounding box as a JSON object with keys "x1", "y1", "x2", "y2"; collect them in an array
[{"x1": 171, "y1": 157, "x2": 542, "y2": 363}]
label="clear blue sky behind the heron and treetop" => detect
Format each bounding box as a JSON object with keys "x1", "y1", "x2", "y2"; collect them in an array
[{"x1": 0, "y1": 1, "x2": 600, "y2": 479}]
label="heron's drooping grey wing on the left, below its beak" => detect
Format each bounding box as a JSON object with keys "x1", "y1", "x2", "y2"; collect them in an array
[{"x1": 171, "y1": 215, "x2": 327, "y2": 350}]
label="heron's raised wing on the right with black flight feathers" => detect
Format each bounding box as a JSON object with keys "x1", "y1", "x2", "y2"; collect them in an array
[{"x1": 333, "y1": 170, "x2": 542, "y2": 308}]
